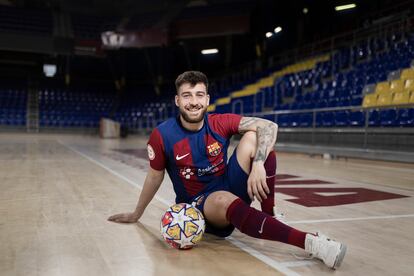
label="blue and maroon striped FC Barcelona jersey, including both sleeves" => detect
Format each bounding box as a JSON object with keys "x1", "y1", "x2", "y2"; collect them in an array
[{"x1": 148, "y1": 114, "x2": 242, "y2": 202}]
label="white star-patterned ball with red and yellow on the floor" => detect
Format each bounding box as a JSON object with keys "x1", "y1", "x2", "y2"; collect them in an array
[{"x1": 161, "y1": 203, "x2": 205, "y2": 249}]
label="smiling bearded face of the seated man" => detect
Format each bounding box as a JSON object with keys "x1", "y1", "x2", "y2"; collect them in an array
[{"x1": 175, "y1": 83, "x2": 210, "y2": 123}]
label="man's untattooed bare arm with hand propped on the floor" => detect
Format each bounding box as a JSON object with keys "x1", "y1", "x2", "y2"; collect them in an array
[{"x1": 108, "y1": 167, "x2": 165, "y2": 223}]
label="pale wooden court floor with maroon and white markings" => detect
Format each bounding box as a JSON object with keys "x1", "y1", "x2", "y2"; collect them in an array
[{"x1": 0, "y1": 134, "x2": 414, "y2": 275}]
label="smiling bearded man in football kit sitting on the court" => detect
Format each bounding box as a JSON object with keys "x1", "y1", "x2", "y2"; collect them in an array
[{"x1": 108, "y1": 71, "x2": 346, "y2": 269}]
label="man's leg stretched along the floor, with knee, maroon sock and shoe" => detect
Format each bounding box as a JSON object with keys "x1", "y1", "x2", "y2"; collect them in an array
[{"x1": 204, "y1": 191, "x2": 346, "y2": 268}]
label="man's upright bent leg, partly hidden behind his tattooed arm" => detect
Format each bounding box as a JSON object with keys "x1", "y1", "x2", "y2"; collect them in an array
[{"x1": 236, "y1": 131, "x2": 276, "y2": 216}]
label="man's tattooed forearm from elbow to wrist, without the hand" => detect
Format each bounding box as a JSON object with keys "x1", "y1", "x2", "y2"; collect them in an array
[{"x1": 253, "y1": 123, "x2": 277, "y2": 162}]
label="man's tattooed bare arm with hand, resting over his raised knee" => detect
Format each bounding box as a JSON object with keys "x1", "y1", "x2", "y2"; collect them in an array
[{"x1": 239, "y1": 117, "x2": 278, "y2": 202}]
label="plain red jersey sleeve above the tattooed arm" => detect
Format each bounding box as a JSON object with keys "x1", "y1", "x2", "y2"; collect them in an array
[{"x1": 209, "y1": 113, "x2": 242, "y2": 138}]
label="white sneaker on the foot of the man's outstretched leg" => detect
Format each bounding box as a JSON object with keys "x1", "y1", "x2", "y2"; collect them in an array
[{"x1": 305, "y1": 233, "x2": 346, "y2": 269}]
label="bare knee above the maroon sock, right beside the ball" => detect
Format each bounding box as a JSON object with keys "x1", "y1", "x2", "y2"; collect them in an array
[{"x1": 204, "y1": 191, "x2": 237, "y2": 227}]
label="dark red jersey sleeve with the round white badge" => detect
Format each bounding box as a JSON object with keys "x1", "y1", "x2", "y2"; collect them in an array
[{"x1": 147, "y1": 128, "x2": 166, "y2": 171}]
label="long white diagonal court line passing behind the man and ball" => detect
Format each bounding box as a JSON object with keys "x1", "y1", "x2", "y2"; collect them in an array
[{"x1": 58, "y1": 140, "x2": 300, "y2": 276}]
